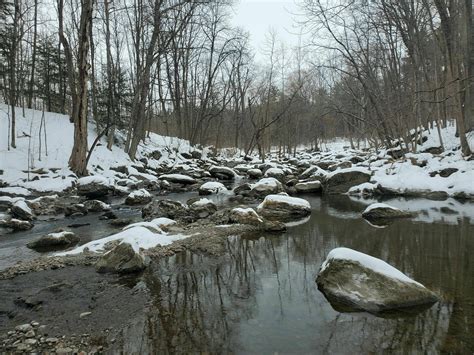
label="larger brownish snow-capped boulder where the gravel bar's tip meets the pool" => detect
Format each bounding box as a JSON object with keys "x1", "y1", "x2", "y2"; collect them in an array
[{"x1": 257, "y1": 194, "x2": 311, "y2": 220}]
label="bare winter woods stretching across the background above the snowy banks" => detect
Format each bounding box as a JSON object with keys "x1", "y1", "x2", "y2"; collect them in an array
[{"x1": 0, "y1": 0, "x2": 474, "y2": 175}]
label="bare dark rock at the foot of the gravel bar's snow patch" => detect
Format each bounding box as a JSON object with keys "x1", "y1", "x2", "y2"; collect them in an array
[{"x1": 95, "y1": 243, "x2": 146, "y2": 274}]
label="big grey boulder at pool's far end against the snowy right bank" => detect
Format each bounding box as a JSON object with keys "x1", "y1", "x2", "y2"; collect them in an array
[{"x1": 323, "y1": 168, "x2": 371, "y2": 194}]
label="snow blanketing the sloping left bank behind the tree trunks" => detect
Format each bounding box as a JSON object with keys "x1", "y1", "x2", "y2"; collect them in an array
[{"x1": 0, "y1": 104, "x2": 202, "y2": 196}]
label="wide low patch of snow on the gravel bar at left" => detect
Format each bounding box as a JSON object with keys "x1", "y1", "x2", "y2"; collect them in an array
[{"x1": 60, "y1": 226, "x2": 189, "y2": 256}]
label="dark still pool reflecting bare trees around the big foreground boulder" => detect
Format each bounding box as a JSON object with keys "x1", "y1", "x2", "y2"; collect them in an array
[{"x1": 114, "y1": 196, "x2": 474, "y2": 354}]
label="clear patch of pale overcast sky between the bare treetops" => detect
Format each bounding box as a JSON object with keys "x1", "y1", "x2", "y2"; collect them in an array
[{"x1": 232, "y1": 0, "x2": 298, "y2": 60}]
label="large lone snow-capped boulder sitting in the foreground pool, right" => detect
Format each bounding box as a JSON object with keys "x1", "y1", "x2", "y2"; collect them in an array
[{"x1": 316, "y1": 248, "x2": 438, "y2": 313}]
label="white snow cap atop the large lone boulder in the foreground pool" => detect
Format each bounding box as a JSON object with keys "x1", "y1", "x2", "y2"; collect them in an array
[{"x1": 319, "y1": 247, "x2": 424, "y2": 287}]
